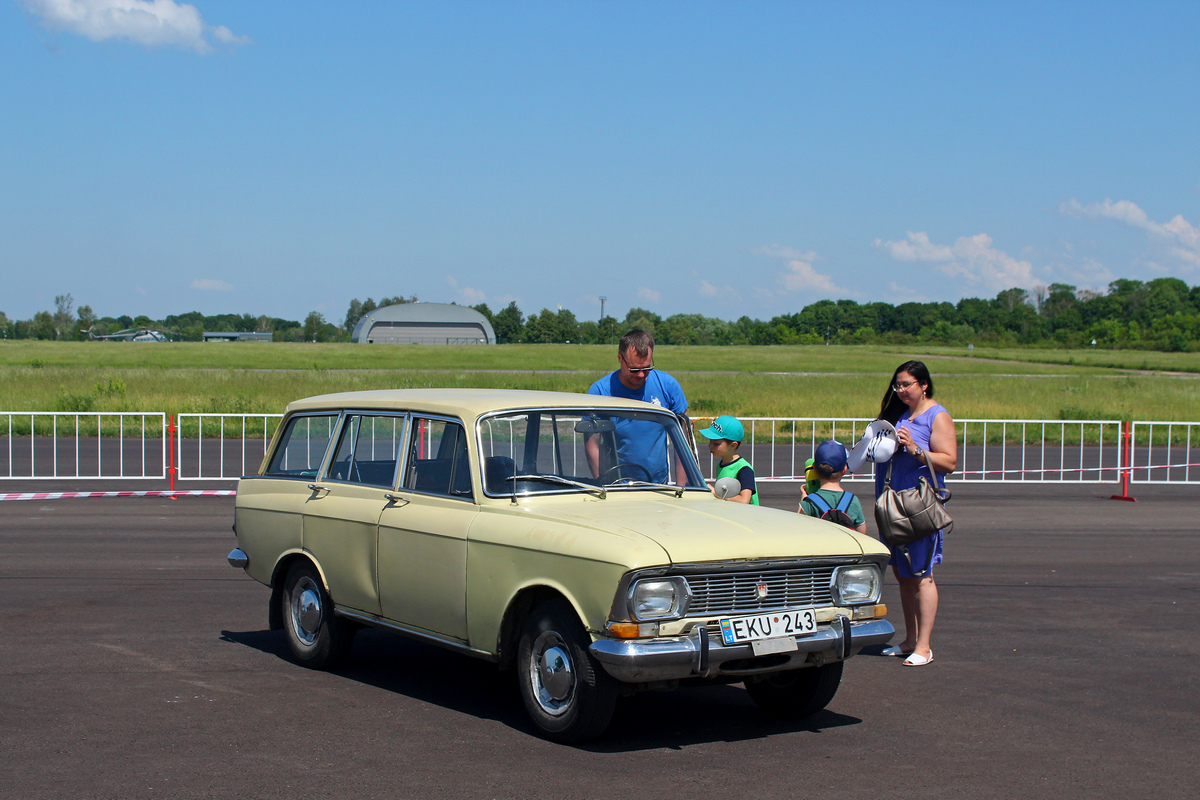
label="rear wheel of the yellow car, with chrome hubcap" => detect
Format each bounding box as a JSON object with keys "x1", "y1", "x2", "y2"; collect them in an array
[{"x1": 281, "y1": 563, "x2": 358, "y2": 669}]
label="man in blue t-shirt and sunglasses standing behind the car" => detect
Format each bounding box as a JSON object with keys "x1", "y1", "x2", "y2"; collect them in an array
[{"x1": 587, "y1": 329, "x2": 691, "y2": 486}]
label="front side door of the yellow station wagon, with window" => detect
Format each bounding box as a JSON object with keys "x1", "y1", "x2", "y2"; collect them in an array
[{"x1": 379, "y1": 415, "x2": 479, "y2": 642}]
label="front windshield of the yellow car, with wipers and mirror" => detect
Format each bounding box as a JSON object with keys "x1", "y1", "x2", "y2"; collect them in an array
[{"x1": 479, "y1": 408, "x2": 707, "y2": 497}]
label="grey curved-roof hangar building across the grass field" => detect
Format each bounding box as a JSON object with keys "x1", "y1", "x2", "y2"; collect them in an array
[{"x1": 350, "y1": 302, "x2": 496, "y2": 344}]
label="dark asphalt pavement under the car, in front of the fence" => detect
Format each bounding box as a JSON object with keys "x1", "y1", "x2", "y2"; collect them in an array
[{"x1": 0, "y1": 486, "x2": 1200, "y2": 800}]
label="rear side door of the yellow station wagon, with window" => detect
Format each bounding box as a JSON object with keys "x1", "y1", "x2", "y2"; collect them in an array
[{"x1": 304, "y1": 411, "x2": 404, "y2": 614}]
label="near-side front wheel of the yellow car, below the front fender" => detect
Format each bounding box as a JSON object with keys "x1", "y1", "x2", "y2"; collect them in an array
[{"x1": 517, "y1": 599, "x2": 618, "y2": 741}]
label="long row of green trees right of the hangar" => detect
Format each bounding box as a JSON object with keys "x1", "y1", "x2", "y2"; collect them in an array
[{"x1": 475, "y1": 278, "x2": 1200, "y2": 351}]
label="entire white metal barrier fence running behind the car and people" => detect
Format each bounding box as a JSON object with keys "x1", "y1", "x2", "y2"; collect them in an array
[{"x1": 0, "y1": 411, "x2": 1200, "y2": 483}]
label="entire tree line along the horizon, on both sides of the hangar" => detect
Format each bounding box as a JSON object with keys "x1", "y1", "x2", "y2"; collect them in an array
[{"x1": 7, "y1": 278, "x2": 1200, "y2": 351}]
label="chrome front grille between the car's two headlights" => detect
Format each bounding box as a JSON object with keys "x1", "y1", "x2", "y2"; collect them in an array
[{"x1": 686, "y1": 566, "x2": 834, "y2": 616}]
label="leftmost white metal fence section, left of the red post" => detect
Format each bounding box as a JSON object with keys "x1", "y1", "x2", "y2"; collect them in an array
[{"x1": 0, "y1": 411, "x2": 168, "y2": 481}]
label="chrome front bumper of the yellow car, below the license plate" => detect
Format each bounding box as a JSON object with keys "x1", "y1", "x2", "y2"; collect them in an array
[{"x1": 589, "y1": 616, "x2": 895, "y2": 684}]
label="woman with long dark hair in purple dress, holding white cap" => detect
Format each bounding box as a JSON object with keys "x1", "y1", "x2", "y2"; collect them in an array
[{"x1": 875, "y1": 361, "x2": 959, "y2": 667}]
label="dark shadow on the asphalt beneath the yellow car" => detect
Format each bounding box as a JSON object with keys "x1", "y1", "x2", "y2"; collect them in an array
[{"x1": 221, "y1": 628, "x2": 862, "y2": 753}]
